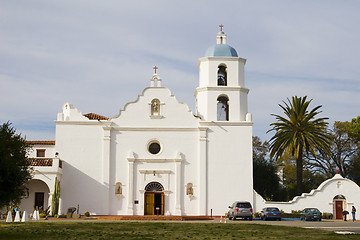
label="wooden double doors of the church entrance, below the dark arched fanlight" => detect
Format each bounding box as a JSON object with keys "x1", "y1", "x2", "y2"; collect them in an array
[{"x1": 144, "y1": 192, "x2": 164, "y2": 215}]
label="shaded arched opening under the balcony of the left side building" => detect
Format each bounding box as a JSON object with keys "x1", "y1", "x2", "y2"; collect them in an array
[{"x1": 20, "y1": 179, "x2": 51, "y2": 212}]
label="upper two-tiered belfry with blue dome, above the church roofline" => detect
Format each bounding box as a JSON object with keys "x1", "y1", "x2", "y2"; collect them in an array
[{"x1": 195, "y1": 28, "x2": 251, "y2": 122}]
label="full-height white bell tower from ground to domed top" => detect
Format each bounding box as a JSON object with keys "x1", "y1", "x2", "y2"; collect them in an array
[{"x1": 195, "y1": 25, "x2": 254, "y2": 215}]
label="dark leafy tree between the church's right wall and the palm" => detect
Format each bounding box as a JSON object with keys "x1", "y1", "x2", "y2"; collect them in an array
[{"x1": 253, "y1": 136, "x2": 281, "y2": 200}]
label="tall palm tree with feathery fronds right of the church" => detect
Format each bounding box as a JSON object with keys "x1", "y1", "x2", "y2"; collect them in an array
[{"x1": 268, "y1": 96, "x2": 331, "y2": 195}]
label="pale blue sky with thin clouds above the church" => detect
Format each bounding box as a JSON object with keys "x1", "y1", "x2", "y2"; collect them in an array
[{"x1": 0, "y1": 0, "x2": 360, "y2": 141}]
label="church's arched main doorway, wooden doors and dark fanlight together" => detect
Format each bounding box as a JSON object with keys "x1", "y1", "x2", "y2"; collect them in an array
[{"x1": 144, "y1": 182, "x2": 165, "y2": 215}]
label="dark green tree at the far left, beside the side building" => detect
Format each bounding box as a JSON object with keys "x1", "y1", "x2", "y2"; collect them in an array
[{"x1": 0, "y1": 122, "x2": 32, "y2": 208}]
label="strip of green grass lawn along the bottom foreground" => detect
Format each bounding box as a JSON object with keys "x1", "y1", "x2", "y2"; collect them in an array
[{"x1": 0, "y1": 221, "x2": 359, "y2": 240}]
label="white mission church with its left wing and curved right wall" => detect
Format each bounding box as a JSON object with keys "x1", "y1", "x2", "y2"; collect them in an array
[{"x1": 21, "y1": 31, "x2": 360, "y2": 216}]
